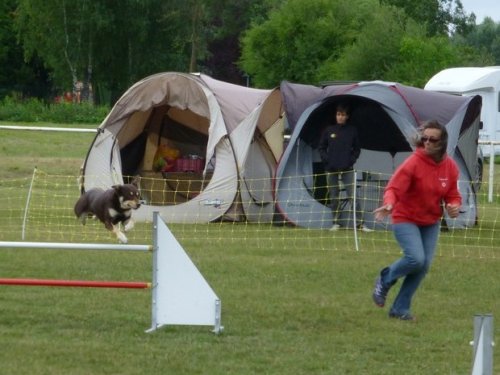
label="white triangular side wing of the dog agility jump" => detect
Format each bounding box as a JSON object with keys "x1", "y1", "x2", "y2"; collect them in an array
[{"x1": 146, "y1": 212, "x2": 223, "y2": 333}]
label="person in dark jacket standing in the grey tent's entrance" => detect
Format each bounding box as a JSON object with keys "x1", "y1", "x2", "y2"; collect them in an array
[{"x1": 318, "y1": 104, "x2": 372, "y2": 232}]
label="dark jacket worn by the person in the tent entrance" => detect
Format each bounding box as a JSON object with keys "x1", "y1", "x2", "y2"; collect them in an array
[{"x1": 318, "y1": 123, "x2": 361, "y2": 172}]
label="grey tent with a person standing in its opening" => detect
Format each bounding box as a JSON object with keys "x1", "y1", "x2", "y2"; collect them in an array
[{"x1": 275, "y1": 81, "x2": 481, "y2": 229}]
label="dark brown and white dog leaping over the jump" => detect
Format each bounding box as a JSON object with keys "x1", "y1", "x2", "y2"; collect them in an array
[{"x1": 74, "y1": 184, "x2": 141, "y2": 243}]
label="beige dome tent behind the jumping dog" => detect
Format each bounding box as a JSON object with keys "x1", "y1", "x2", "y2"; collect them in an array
[{"x1": 82, "y1": 72, "x2": 283, "y2": 223}]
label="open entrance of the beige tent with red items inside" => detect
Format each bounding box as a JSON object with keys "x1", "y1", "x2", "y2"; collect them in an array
[{"x1": 121, "y1": 105, "x2": 215, "y2": 206}]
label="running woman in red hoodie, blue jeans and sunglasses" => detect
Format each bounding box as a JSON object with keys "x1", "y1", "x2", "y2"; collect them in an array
[{"x1": 372, "y1": 121, "x2": 462, "y2": 320}]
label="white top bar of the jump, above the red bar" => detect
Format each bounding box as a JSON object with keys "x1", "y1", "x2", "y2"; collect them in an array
[{"x1": 0, "y1": 241, "x2": 153, "y2": 251}]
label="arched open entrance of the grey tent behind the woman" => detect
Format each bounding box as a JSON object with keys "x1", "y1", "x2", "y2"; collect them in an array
[{"x1": 278, "y1": 95, "x2": 412, "y2": 227}]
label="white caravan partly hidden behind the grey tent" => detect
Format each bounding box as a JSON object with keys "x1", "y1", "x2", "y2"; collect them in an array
[{"x1": 425, "y1": 66, "x2": 500, "y2": 155}]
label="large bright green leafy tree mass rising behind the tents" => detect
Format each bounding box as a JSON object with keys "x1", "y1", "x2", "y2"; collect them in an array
[{"x1": 241, "y1": 0, "x2": 487, "y2": 87}]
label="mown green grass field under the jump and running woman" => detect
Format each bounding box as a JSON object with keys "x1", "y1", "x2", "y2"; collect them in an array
[{"x1": 0, "y1": 122, "x2": 500, "y2": 375}]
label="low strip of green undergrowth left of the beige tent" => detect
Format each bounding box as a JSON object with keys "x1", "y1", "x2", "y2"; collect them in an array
[{"x1": 0, "y1": 96, "x2": 109, "y2": 124}]
